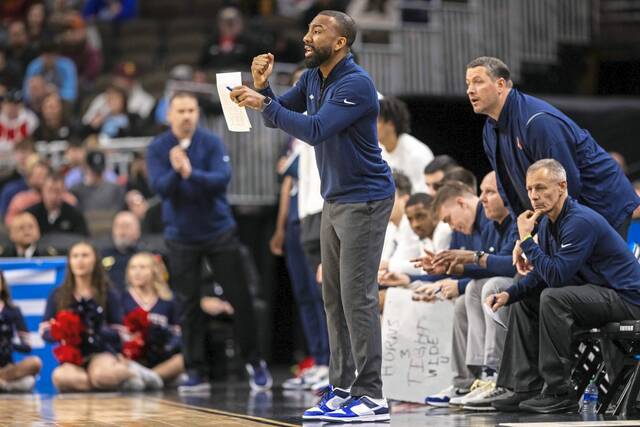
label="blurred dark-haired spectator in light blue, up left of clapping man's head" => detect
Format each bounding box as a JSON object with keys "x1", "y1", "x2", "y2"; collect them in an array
[{"x1": 86, "y1": 85, "x2": 137, "y2": 138}]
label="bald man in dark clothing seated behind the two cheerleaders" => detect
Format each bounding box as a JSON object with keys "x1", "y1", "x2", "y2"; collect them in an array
[{"x1": 101, "y1": 211, "x2": 141, "y2": 292}]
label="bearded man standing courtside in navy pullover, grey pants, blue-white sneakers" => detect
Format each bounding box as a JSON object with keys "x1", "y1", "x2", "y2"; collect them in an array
[{"x1": 230, "y1": 11, "x2": 394, "y2": 422}]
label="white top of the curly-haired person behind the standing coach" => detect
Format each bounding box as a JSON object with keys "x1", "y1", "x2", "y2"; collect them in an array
[{"x1": 380, "y1": 133, "x2": 433, "y2": 193}]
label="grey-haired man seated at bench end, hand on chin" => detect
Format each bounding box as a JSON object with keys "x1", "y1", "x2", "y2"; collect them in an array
[{"x1": 485, "y1": 159, "x2": 640, "y2": 413}]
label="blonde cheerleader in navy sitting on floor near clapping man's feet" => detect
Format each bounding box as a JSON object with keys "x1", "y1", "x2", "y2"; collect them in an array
[{"x1": 122, "y1": 252, "x2": 184, "y2": 385}]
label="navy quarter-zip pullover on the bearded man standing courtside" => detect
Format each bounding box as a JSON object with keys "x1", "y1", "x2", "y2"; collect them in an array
[{"x1": 260, "y1": 54, "x2": 395, "y2": 203}]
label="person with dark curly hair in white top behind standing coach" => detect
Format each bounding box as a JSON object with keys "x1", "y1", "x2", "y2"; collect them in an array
[{"x1": 378, "y1": 97, "x2": 433, "y2": 193}]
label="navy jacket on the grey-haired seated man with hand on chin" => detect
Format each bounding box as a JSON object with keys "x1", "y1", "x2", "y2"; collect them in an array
[{"x1": 507, "y1": 198, "x2": 640, "y2": 305}]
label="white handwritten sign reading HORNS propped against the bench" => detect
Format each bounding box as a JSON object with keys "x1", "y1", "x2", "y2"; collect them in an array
[{"x1": 382, "y1": 288, "x2": 453, "y2": 403}]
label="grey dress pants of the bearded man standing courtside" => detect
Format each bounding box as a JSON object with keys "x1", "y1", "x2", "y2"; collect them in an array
[{"x1": 320, "y1": 198, "x2": 394, "y2": 399}]
